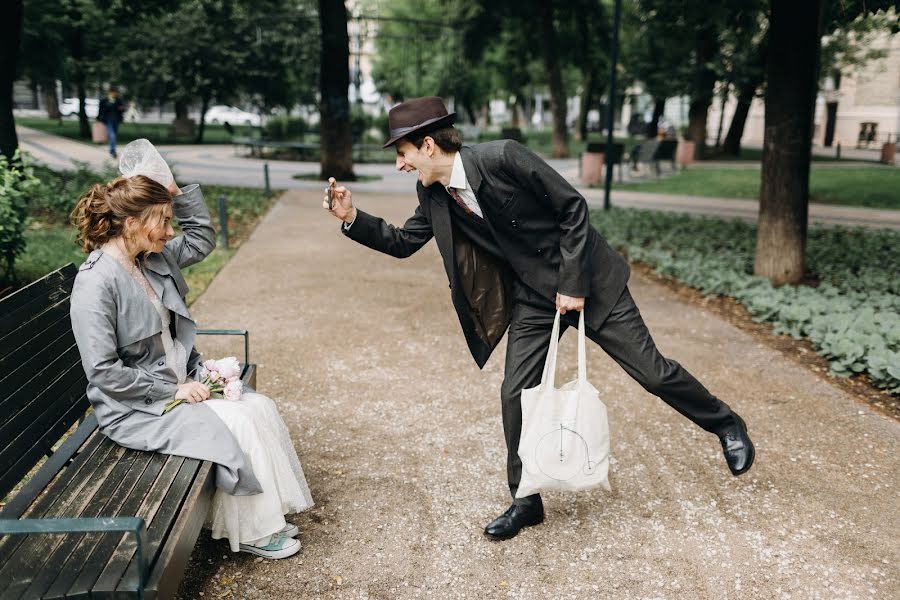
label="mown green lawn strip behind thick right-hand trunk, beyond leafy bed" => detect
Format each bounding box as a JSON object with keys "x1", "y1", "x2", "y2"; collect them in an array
[{"x1": 615, "y1": 165, "x2": 900, "y2": 210}]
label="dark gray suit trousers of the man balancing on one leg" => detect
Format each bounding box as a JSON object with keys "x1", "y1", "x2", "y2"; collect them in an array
[{"x1": 500, "y1": 281, "x2": 734, "y2": 504}]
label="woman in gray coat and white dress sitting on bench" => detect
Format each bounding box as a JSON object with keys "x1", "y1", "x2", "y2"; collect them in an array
[{"x1": 70, "y1": 175, "x2": 312, "y2": 558}]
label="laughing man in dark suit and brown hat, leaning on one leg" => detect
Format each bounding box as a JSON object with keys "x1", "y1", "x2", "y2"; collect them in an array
[{"x1": 324, "y1": 97, "x2": 754, "y2": 539}]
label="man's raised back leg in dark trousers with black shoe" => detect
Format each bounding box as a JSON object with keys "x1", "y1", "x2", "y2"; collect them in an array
[{"x1": 588, "y1": 288, "x2": 755, "y2": 475}]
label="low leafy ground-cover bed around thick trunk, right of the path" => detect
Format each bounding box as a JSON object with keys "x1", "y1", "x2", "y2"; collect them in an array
[{"x1": 592, "y1": 209, "x2": 900, "y2": 394}]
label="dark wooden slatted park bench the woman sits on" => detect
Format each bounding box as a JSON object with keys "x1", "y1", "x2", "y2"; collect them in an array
[{"x1": 0, "y1": 264, "x2": 256, "y2": 600}]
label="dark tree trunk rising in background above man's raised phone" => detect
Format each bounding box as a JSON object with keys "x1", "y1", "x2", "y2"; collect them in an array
[{"x1": 319, "y1": 0, "x2": 356, "y2": 181}]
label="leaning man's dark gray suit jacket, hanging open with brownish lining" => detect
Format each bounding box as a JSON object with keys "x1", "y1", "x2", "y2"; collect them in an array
[{"x1": 344, "y1": 140, "x2": 630, "y2": 367}]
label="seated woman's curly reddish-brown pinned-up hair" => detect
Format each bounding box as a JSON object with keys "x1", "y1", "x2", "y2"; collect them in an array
[{"x1": 71, "y1": 175, "x2": 172, "y2": 253}]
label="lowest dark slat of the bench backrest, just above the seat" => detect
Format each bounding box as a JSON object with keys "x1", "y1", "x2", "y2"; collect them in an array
[{"x1": 0, "y1": 374, "x2": 89, "y2": 500}]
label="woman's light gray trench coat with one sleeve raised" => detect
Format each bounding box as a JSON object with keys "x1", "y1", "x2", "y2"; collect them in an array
[{"x1": 70, "y1": 185, "x2": 262, "y2": 495}]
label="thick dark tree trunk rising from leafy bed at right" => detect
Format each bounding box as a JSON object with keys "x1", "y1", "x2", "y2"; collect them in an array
[{"x1": 753, "y1": 0, "x2": 823, "y2": 285}]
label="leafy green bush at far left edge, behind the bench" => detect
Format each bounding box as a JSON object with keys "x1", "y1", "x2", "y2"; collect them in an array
[{"x1": 0, "y1": 151, "x2": 41, "y2": 285}]
